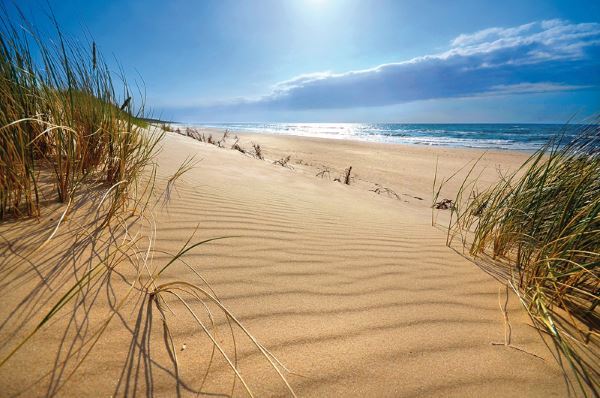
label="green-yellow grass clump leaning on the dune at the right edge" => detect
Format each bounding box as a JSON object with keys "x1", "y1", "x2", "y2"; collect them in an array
[{"x1": 450, "y1": 125, "x2": 600, "y2": 395}]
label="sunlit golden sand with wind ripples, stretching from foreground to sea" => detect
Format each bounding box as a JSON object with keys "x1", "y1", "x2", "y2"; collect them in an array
[{"x1": 0, "y1": 133, "x2": 566, "y2": 397}]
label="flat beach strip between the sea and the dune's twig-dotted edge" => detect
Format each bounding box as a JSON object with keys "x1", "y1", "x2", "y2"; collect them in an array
[{"x1": 171, "y1": 128, "x2": 531, "y2": 209}]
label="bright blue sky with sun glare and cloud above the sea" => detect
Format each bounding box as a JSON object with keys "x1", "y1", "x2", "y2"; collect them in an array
[{"x1": 10, "y1": 0, "x2": 600, "y2": 123}]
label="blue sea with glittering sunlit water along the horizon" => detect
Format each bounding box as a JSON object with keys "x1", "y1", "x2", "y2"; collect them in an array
[{"x1": 196, "y1": 123, "x2": 582, "y2": 151}]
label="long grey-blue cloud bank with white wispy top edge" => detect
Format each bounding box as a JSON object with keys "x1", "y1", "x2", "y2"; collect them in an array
[{"x1": 185, "y1": 20, "x2": 600, "y2": 110}]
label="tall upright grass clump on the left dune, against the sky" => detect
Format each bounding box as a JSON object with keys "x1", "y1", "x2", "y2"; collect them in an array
[{"x1": 0, "y1": 8, "x2": 160, "y2": 219}]
